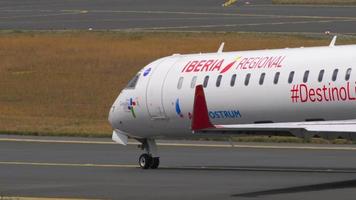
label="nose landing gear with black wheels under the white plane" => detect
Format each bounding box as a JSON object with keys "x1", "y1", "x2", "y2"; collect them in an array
[{"x1": 138, "y1": 139, "x2": 159, "y2": 169}]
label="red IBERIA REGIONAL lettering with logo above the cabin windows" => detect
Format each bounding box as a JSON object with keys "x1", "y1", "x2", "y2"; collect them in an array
[{"x1": 182, "y1": 56, "x2": 286, "y2": 74}]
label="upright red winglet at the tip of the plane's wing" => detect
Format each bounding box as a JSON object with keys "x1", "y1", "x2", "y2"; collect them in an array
[{"x1": 192, "y1": 85, "x2": 215, "y2": 131}]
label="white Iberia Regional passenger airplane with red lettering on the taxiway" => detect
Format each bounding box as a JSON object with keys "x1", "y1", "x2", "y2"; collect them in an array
[{"x1": 108, "y1": 36, "x2": 356, "y2": 169}]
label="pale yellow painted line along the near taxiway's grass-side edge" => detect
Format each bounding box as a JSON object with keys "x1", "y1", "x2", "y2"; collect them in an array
[{"x1": 0, "y1": 138, "x2": 356, "y2": 151}]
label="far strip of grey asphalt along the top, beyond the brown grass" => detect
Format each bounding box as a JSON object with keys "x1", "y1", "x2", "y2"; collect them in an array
[{"x1": 0, "y1": 0, "x2": 356, "y2": 34}]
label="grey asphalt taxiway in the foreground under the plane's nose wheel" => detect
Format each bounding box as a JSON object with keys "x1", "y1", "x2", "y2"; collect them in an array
[{"x1": 0, "y1": 136, "x2": 356, "y2": 200}]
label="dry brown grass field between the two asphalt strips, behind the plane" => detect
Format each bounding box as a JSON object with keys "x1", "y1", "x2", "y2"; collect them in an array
[{"x1": 0, "y1": 32, "x2": 351, "y2": 137}]
